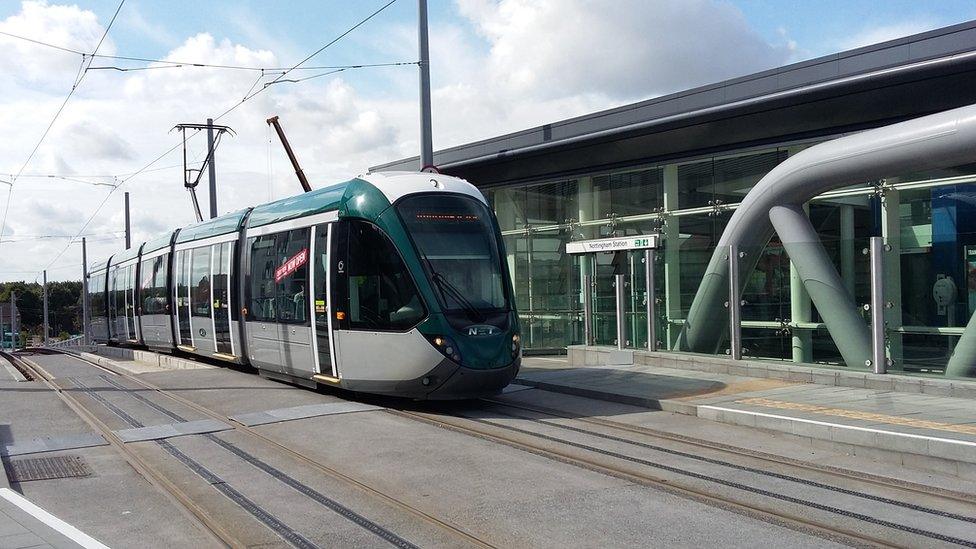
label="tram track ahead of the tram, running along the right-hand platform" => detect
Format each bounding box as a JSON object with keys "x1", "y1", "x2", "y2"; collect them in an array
[{"x1": 390, "y1": 401, "x2": 976, "y2": 547}]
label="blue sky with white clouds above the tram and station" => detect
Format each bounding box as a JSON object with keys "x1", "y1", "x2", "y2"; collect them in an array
[{"x1": 0, "y1": 0, "x2": 976, "y2": 281}]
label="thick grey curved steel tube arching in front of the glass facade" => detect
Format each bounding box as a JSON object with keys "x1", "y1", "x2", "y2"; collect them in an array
[{"x1": 677, "y1": 105, "x2": 976, "y2": 375}]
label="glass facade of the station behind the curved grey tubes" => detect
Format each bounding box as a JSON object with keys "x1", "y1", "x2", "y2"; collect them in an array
[{"x1": 484, "y1": 143, "x2": 976, "y2": 377}]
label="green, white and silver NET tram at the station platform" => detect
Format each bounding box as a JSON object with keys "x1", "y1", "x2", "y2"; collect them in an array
[{"x1": 87, "y1": 172, "x2": 522, "y2": 399}]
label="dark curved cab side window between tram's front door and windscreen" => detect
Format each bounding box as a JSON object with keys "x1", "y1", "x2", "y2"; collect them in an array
[{"x1": 347, "y1": 221, "x2": 426, "y2": 330}]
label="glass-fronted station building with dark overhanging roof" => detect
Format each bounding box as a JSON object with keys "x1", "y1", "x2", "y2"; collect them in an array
[{"x1": 373, "y1": 22, "x2": 976, "y2": 382}]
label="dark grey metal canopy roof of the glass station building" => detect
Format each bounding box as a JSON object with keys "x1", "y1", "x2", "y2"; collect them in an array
[{"x1": 372, "y1": 21, "x2": 976, "y2": 187}]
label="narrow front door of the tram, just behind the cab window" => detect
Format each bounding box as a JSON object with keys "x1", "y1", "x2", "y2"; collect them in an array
[{"x1": 312, "y1": 223, "x2": 338, "y2": 377}]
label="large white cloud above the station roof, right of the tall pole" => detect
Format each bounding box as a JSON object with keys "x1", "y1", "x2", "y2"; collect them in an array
[{"x1": 458, "y1": 0, "x2": 790, "y2": 98}]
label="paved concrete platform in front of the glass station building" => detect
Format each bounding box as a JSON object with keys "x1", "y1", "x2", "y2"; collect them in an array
[{"x1": 517, "y1": 357, "x2": 976, "y2": 479}]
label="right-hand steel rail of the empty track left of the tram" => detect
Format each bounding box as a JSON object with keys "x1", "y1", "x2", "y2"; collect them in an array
[{"x1": 42, "y1": 349, "x2": 495, "y2": 549}]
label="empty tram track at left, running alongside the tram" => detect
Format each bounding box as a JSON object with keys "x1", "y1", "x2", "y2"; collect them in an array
[{"x1": 17, "y1": 351, "x2": 493, "y2": 548}]
